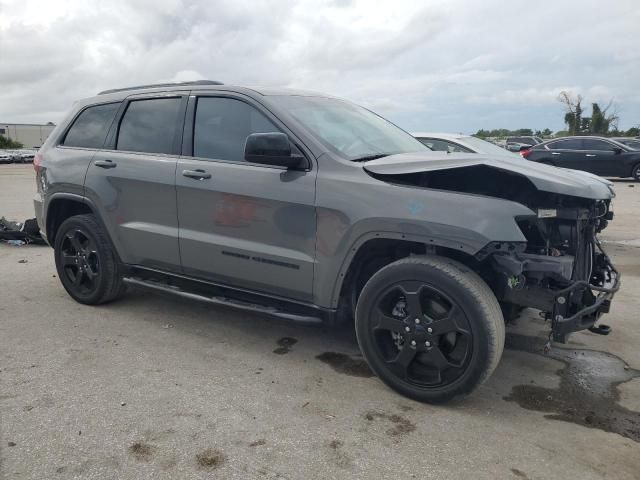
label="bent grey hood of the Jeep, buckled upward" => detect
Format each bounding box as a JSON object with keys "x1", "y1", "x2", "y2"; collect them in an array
[{"x1": 363, "y1": 152, "x2": 615, "y2": 200}]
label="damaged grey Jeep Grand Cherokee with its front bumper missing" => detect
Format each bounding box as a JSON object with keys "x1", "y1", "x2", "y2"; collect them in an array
[{"x1": 34, "y1": 81, "x2": 620, "y2": 403}]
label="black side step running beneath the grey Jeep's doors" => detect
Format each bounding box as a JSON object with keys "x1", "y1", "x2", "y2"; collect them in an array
[{"x1": 123, "y1": 277, "x2": 323, "y2": 324}]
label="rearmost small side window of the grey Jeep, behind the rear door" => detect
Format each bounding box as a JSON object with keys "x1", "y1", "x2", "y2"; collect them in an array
[{"x1": 62, "y1": 103, "x2": 120, "y2": 148}]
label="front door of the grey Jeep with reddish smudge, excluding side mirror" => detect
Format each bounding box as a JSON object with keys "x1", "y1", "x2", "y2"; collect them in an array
[{"x1": 176, "y1": 93, "x2": 316, "y2": 300}]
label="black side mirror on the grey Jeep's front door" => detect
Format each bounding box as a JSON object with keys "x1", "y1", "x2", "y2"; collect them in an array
[{"x1": 244, "y1": 132, "x2": 304, "y2": 168}]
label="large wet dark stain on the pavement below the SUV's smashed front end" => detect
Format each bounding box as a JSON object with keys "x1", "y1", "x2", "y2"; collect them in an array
[{"x1": 504, "y1": 334, "x2": 640, "y2": 442}]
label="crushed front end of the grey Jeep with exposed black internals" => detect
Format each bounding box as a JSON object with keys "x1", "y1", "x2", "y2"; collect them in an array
[{"x1": 477, "y1": 195, "x2": 620, "y2": 343}]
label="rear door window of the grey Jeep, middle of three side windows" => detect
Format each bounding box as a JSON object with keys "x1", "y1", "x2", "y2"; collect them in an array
[{"x1": 116, "y1": 98, "x2": 181, "y2": 153}]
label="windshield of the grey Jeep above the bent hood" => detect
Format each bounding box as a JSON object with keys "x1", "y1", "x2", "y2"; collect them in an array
[{"x1": 270, "y1": 95, "x2": 428, "y2": 161}]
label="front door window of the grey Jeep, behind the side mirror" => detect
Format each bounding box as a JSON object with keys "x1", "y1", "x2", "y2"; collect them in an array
[{"x1": 193, "y1": 97, "x2": 280, "y2": 161}]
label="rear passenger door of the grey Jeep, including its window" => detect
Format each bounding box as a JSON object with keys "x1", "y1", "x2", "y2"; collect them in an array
[{"x1": 85, "y1": 92, "x2": 187, "y2": 271}]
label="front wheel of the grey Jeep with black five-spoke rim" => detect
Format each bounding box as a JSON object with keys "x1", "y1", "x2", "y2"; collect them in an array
[{"x1": 356, "y1": 256, "x2": 505, "y2": 403}]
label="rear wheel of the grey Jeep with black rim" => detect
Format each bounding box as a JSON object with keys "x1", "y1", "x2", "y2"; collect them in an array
[{"x1": 54, "y1": 215, "x2": 126, "y2": 305}]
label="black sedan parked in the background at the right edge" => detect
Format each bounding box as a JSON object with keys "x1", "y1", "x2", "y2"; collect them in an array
[{"x1": 520, "y1": 137, "x2": 640, "y2": 181}]
